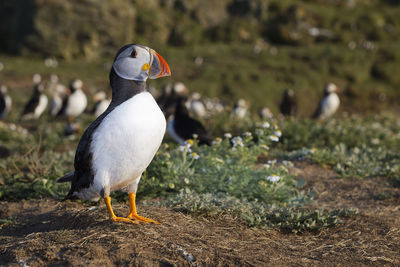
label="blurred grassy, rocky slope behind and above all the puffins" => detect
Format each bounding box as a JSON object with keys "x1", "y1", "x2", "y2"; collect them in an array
[{"x1": 0, "y1": 0, "x2": 400, "y2": 116}]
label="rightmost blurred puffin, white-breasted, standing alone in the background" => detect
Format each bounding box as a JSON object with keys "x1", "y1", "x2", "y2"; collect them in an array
[{"x1": 313, "y1": 83, "x2": 340, "y2": 120}]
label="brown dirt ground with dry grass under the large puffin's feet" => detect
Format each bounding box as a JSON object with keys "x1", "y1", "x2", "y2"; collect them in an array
[{"x1": 0, "y1": 162, "x2": 400, "y2": 266}]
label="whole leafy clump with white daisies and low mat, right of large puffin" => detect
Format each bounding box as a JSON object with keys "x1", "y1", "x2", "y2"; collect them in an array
[{"x1": 139, "y1": 123, "x2": 352, "y2": 233}]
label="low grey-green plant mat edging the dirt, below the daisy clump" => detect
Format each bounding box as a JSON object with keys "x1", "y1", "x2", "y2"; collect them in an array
[{"x1": 165, "y1": 190, "x2": 358, "y2": 233}]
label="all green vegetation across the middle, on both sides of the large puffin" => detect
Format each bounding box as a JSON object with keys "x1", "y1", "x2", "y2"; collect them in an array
[{"x1": 0, "y1": 112, "x2": 400, "y2": 232}]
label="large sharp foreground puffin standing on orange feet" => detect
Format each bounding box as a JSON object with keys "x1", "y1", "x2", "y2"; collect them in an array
[{"x1": 58, "y1": 44, "x2": 171, "y2": 224}]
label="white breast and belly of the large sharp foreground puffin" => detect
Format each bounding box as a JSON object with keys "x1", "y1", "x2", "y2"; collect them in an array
[{"x1": 77, "y1": 92, "x2": 166, "y2": 201}]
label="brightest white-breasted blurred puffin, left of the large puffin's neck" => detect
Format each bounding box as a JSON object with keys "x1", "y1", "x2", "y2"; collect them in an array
[{"x1": 58, "y1": 79, "x2": 87, "y2": 121}]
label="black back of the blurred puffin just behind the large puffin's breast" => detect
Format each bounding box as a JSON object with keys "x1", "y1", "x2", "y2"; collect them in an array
[{"x1": 174, "y1": 97, "x2": 214, "y2": 146}]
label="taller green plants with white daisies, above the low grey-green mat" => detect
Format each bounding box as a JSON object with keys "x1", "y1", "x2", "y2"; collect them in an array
[{"x1": 139, "y1": 123, "x2": 288, "y2": 200}]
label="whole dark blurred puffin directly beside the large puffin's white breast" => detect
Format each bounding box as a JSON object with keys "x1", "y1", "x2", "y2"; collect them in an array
[{"x1": 167, "y1": 97, "x2": 214, "y2": 146}]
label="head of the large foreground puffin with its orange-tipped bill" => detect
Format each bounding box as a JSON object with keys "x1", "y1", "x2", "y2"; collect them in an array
[{"x1": 113, "y1": 45, "x2": 171, "y2": 81}]
